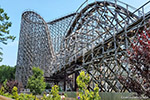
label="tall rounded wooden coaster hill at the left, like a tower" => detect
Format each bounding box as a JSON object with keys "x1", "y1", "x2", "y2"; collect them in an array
[{"x1": 16, "y1": 11, "x2": 54, "y2": 86}]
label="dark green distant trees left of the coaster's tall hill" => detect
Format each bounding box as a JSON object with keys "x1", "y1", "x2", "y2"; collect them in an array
[{"x1": 0, "y1": 65, "x2": 16, "y2": 83}]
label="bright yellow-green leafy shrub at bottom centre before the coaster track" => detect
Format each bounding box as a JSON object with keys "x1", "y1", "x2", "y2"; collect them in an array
[{"x1": 76, "y1": 71, "x2": 101, "y2": 100}]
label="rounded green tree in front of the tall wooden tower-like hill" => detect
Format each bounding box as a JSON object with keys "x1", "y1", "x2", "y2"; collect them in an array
[{"x1": 27, "y1": 67, "x2": 46, "y2": 95}]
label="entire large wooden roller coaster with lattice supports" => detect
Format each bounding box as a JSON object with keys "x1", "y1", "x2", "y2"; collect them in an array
[{"x1": 16, "y1": 0, "x2": 150, "y2": 92}]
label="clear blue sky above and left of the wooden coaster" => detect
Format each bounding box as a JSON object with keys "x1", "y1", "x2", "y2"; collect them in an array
[{"x1": 0, "y1": 0, "x2": 149, "y2": 66}]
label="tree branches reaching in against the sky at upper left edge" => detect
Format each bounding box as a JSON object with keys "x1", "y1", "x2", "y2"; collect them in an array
[{"x1": 0, "y1": 8, "x2": 15, "y2": 62}]
